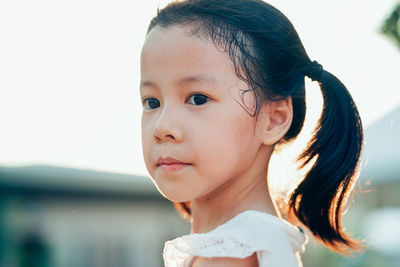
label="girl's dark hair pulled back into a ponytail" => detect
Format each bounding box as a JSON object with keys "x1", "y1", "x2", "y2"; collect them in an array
[{"x1": 148, "y1": 0, "x2": 363, "y2": 253}]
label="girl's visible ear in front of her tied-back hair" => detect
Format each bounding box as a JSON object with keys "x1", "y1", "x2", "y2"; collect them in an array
[{"x1": 257, "y1": 97, "x2": 293, "y2": 145}]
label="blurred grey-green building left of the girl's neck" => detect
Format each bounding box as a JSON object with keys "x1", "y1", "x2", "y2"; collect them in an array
[{"x1": 0, "y1": 166, "x2": 189, "y2": 267}]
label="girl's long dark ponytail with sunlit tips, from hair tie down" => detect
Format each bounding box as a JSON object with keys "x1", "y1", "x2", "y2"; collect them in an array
[{"x1": 289, "y1": 61, "x2": 363, "y2": 253}]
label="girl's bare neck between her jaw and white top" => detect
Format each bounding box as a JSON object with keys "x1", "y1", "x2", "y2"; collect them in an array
[{"x1": 191, "y1": 150, "x2": 279, "y2": 236}]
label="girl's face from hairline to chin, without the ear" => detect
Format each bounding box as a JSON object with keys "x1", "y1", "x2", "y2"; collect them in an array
[{"x1": 140, "y1": 26, "x2": 266, "y2": 202}]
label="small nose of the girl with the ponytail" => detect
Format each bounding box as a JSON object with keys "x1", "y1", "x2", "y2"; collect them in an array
[{"x1": 154, "y1": 106, "x2": 182, "y2": 143}]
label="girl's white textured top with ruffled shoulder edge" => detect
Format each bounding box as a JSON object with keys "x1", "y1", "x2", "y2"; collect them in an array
[{"x1": 163, "y1": 210, "x2": 307, "y2": 267}]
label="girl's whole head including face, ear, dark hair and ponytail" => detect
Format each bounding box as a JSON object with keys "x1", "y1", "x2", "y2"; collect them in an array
[{"x1": 141, "y1": 0, "x2": 363, "y2": 254}]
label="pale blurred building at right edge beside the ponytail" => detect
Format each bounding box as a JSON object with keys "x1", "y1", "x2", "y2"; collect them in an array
[{"x1": 361, "y1": 107, "x2": 400, "y2": 266}]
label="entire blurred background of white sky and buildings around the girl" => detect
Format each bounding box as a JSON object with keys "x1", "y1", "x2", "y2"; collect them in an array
[{"x1": 0, "y1": 0, "x2": 400, "y2": 267}]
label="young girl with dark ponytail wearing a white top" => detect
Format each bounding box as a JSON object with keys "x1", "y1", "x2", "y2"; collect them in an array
[{"x1": 140, "y1": 0, "x2": 363, "y2": 267}]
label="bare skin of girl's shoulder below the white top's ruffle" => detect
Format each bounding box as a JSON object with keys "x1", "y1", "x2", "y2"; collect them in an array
[{"x1": 192, "y1": 253, "x2": 259, "y2": 267}]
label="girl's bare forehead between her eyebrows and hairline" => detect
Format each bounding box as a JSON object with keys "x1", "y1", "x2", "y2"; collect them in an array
[{"x1": 141, "y1": 25, "x2": 237, "y2": 87}]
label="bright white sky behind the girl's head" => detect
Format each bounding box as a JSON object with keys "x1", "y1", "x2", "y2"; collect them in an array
[{"x1": 0, "y1": 0, "x2": 400, "y2": 178}]
